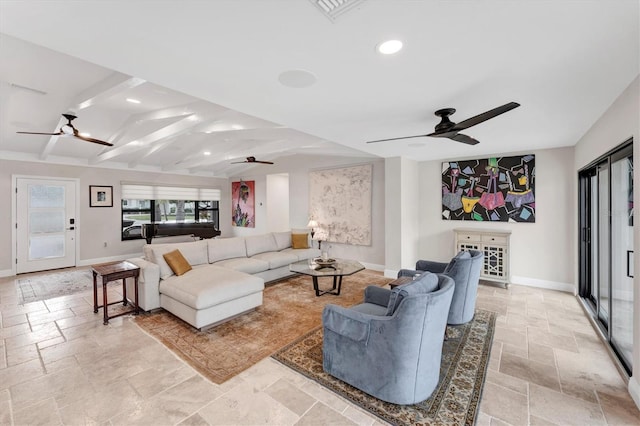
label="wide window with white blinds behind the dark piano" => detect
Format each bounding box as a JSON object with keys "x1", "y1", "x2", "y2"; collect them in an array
[{"x1": 121, "y1": 183, "x2": 220, "y2": 240}]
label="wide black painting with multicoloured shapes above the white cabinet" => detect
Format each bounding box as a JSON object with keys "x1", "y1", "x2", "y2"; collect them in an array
[{"x1": 442, "y1": 154, "x2": 536, "y2": 223}]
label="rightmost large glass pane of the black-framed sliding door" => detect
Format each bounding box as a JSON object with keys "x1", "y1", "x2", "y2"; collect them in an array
[{"x1": 609, "y1": 157, "x2": 633, "y2": 365}]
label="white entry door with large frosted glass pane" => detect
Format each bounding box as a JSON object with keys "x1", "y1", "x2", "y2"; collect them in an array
[{"x1": 16, "y1": 178, "x2": 76, "y2": 274}]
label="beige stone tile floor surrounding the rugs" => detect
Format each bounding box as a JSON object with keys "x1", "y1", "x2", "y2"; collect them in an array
[{"x1": 0, "y1": 276, "x2": 640, "y2": 426}]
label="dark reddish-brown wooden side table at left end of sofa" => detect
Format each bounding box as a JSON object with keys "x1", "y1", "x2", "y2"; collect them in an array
[{"x1": 91, "y1": 260, "x2": 140, "y2": 325}]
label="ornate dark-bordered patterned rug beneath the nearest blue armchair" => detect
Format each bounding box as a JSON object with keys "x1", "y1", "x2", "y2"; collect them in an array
[{"x1": 273, "y1": 310, "x2": 496, "y2": 425}]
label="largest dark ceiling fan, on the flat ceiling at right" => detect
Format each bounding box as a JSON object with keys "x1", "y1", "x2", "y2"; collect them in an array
[{"x1": 367, "y1": 102, "x2": 520, "y2": 145}]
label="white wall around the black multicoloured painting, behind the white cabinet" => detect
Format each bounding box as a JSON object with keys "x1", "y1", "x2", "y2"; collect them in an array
[{"x1": 416, "y1": 147, "x2": 576, "y2": 290}]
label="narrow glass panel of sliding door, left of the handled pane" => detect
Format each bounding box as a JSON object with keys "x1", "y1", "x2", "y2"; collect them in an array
[{"x1": 598, "y1": 166, "x2": 609, "y2": 326}]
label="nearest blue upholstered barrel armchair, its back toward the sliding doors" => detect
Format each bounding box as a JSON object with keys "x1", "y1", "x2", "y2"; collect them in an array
[{"x1": 322, "y1": 274, "x2": 454, "y2": 404}]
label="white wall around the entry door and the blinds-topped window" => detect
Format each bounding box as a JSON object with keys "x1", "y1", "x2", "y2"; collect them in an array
[{"x1": 0, "y1": 160, "x2": 231, "y2": 275}]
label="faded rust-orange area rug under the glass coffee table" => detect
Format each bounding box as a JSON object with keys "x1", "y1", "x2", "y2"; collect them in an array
[{"x1": 135, "y1": 270, "x2": 392, "y2": 384}]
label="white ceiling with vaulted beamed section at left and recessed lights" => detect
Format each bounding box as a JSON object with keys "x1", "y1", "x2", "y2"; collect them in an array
[{"x1": 0, "y1": 0, "x2": 640, "y2": 176}]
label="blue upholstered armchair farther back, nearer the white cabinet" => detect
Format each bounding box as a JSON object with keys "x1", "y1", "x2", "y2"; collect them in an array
[{"x1": 398, "y1": 250, "x2": 484, "y2": 325}]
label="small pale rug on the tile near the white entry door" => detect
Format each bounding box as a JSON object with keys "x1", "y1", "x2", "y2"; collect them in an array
[{"x1": 17, "y1": 268, "x2": 93, "y2": 305}]
